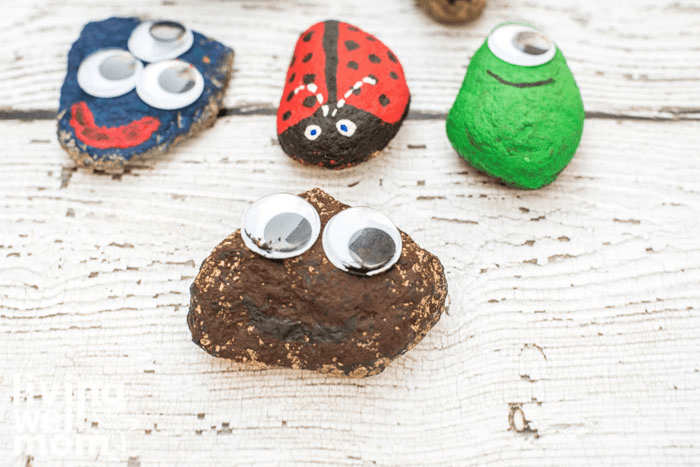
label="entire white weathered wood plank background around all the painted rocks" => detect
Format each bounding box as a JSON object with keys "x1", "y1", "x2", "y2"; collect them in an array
[{"x1": 0, "y1": 0, "x2": 700, "y2": 467}]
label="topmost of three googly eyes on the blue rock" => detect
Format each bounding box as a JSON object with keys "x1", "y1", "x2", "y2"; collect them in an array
[{"x1": 128, "y1": 20, "x2": 194, "y2": 62}]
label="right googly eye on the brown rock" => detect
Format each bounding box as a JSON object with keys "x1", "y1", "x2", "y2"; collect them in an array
[{"x1": 323, "y1": 207, "x2": 402, "y2": 276}]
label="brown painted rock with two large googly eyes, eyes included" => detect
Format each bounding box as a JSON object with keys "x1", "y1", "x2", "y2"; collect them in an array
[{"x1": 187, "y1": 188, "x2": 447, "y2": 378}]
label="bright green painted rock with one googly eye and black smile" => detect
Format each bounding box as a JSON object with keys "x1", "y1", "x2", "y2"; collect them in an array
[{"x1": 447, "y1": 23, "x2": 585, "y2": 189}]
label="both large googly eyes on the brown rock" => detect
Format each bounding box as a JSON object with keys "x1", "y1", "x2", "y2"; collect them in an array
[{"x1": 241, "y1": 193, "x2": 402, "y2": 276}]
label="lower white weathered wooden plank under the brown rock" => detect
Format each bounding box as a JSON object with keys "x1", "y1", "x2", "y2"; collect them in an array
[{"x1": 0, "y1": 114, "x2": 700, "y2": 467}]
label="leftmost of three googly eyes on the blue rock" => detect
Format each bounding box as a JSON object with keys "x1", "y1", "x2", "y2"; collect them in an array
[{"x1": 78, "y1": 49, "x2": 143, "y2": 97}]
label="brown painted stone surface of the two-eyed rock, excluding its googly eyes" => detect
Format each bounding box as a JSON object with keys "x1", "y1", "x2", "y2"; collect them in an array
[{"x1": 187, "y1": 189, "x2": 447, "y2": 378}]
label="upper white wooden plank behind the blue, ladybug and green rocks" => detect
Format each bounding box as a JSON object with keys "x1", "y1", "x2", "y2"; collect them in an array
[{"x1": 0, "y1": 0, "x2": 700, "y2": 119}]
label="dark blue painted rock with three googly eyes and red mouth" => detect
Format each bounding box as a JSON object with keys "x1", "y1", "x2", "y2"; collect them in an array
[{"x1": 58, "y1": 18, "x2": 233, "y2": 172}]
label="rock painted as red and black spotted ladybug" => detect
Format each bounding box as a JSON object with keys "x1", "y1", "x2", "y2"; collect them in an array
[{"x1": 277, "y1": 21, "x2": 411, "y2": 169}]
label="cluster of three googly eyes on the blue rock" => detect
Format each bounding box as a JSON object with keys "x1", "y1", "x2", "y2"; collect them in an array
[{"x1": 78, "y1": 21, "x2": 204, "y2": 110}]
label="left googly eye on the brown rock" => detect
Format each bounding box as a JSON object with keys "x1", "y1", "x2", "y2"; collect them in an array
[{"x1": 241, "y1": 193, "x2": 321, "y2": 259}]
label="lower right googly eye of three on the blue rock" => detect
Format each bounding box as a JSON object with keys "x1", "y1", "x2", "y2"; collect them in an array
[{"x1": 136, "y1": 60, "x2": 204, "y2": 110}]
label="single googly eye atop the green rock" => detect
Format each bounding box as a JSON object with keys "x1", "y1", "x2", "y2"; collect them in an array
[{"x1": 487, "y1": 24, "x2": 557, "y2": 66}]
